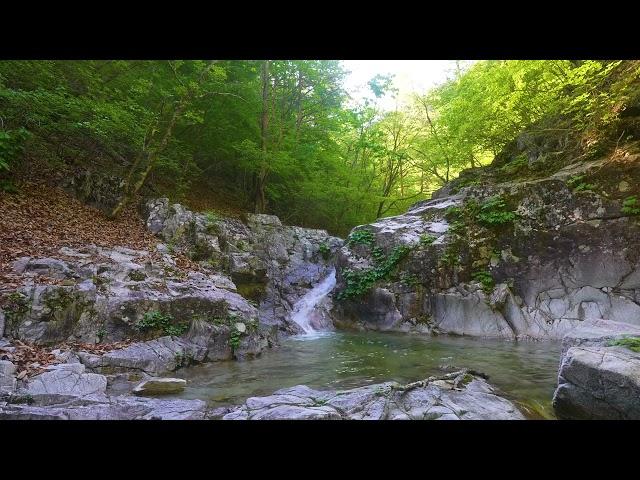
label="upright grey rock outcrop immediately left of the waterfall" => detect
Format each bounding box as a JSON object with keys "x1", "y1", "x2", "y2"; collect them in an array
[{"x1": 146, "y1": 198, "x2": 342, "y2": 333}]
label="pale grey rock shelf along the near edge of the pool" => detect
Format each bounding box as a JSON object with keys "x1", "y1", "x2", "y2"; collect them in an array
[{"x1": 0, "y1": 362, "x2": 524, "y2": 420}]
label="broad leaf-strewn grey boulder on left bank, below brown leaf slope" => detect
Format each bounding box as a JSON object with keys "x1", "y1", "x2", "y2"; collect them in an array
[{"x1": 5, "y1": 247, "x2": 258, "y2": 345}]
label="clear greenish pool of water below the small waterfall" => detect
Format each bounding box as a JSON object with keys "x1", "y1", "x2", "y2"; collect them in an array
[{"x1": 170, "y1": 332, "x2": 560, "y2": 418}]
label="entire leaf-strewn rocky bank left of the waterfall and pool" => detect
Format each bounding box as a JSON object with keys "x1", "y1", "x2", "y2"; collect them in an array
[{"x1": 0, "y1": 193, "x2": 341, "y2": 418}]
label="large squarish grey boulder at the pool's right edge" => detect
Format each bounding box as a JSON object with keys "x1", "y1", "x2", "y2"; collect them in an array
[{"x1": 553, "y1": 321, "x2": 640, "y2": 420}]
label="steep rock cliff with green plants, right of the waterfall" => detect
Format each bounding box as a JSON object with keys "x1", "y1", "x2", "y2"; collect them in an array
[{"x1": 333, "y1": 142, "x2": 640, "y2": 339}]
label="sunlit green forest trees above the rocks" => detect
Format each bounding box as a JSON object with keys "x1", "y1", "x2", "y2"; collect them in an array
[{"x1": 0, "y1": 60, "x2": 638, "y2": 235}]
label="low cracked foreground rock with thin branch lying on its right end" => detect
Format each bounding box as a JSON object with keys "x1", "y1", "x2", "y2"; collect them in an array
[{"x1": 221, "y1": 371, "x2": 524, "y2": 420}]
